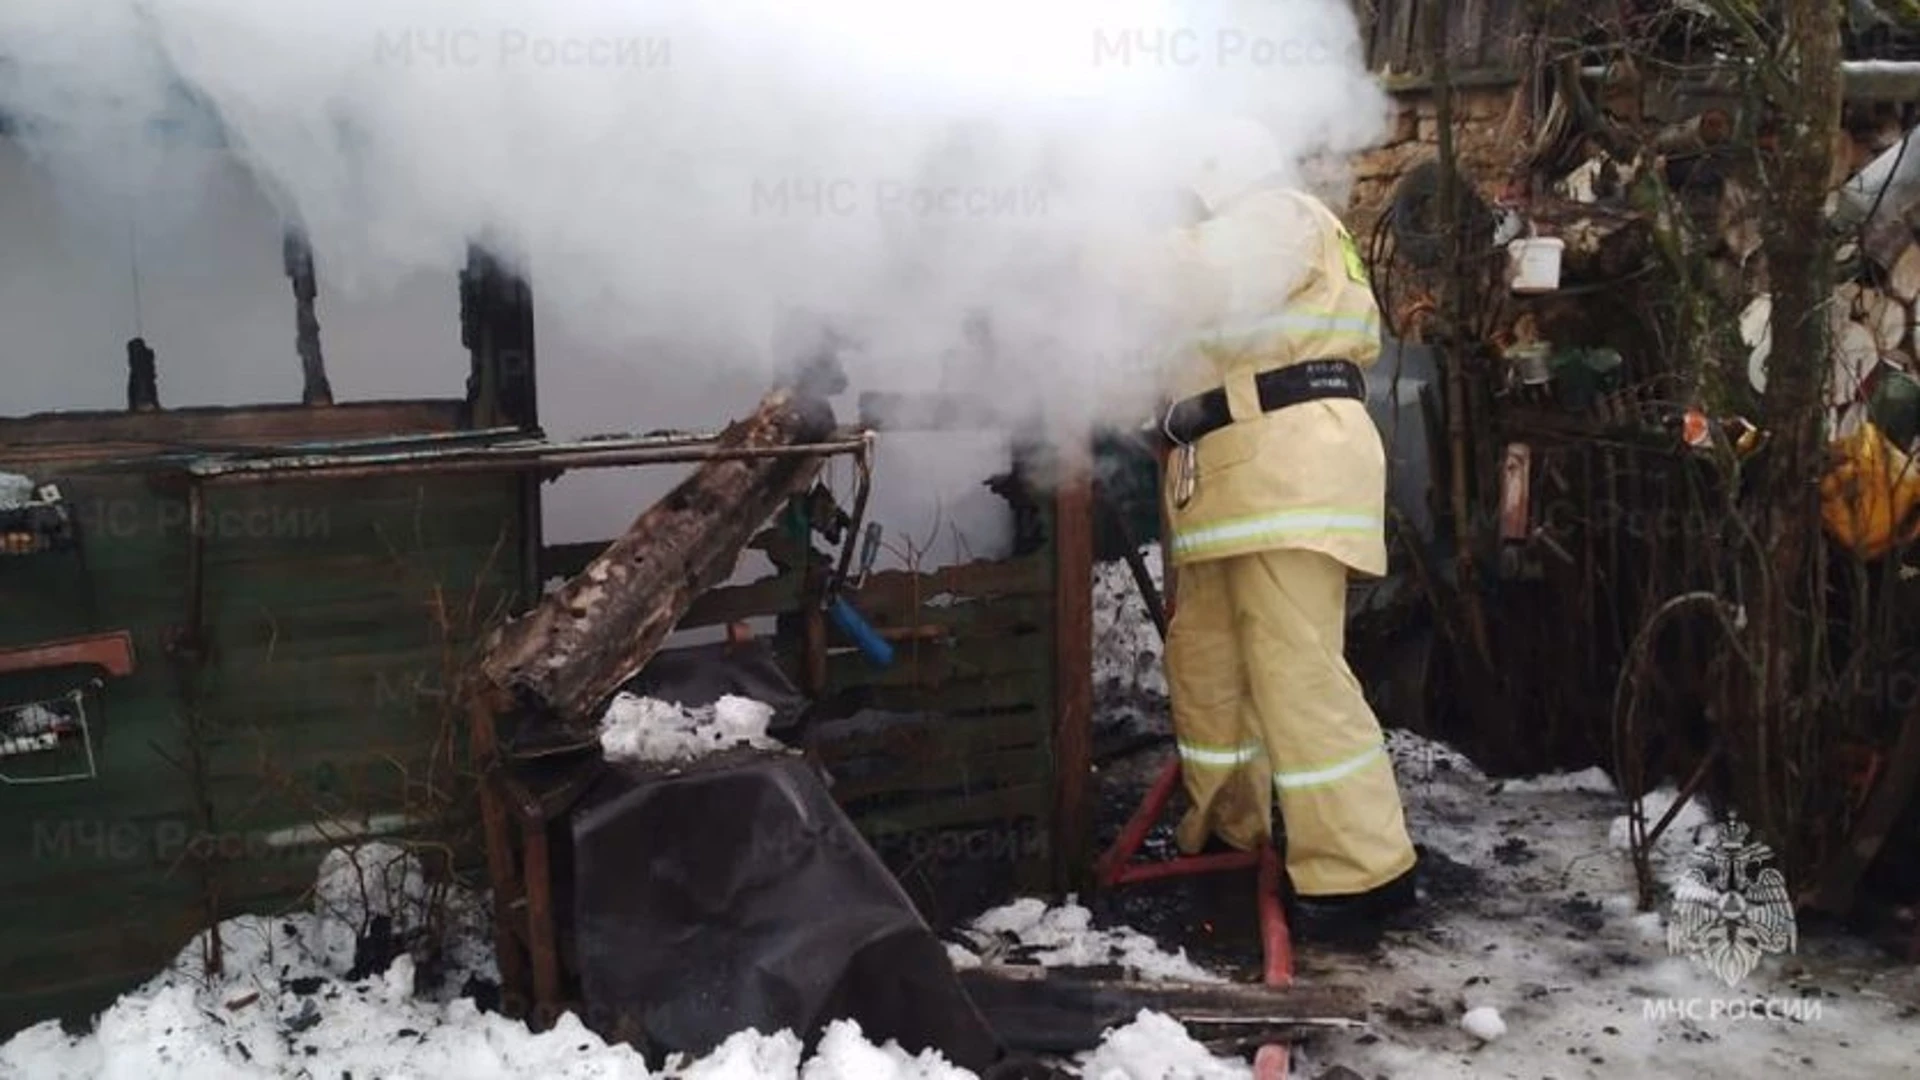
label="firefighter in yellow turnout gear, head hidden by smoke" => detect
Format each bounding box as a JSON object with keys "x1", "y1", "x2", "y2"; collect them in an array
[{"x1": 1162, "y1": 121, "x2": 1417, "y2": 944}]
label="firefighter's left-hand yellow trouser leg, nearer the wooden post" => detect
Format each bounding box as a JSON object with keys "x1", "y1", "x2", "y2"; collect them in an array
[{"x1": 1167, "y1": 563, "x2": 1273, "y2": 855}]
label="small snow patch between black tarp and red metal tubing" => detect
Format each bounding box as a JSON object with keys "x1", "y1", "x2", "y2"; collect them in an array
[{"x1": 962, "y1": 897, "x2": 1225, "y2": 982}]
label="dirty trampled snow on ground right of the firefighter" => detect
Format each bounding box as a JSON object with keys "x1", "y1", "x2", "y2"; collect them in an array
[{"x1": 1298, "y1": 732, "x2": 1920, "y2": 1080}]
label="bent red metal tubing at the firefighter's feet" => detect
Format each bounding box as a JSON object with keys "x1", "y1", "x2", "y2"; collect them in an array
[{"x1": 1094, "y1": 759, "x2": 1294, "y2": 1080}]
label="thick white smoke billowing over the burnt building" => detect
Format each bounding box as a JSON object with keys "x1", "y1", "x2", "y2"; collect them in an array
[{"x1": 0, "y1": 0, "x2": 1386, "y2": 545}]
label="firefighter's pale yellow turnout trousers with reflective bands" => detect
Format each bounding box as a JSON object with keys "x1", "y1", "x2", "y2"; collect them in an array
[{"x1": 1167, "y1": 548, "x2": 1415, "y2": 896}]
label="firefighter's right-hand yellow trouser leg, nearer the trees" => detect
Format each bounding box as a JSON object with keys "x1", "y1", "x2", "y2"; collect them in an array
[{"x1": 1225, "y1": 550, "x2": 1413, "y2": 896}]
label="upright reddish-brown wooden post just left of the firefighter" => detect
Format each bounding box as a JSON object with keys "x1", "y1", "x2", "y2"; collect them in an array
[{"x1": 1052, "y1": 438, "x2": 1092, "y2": 892}]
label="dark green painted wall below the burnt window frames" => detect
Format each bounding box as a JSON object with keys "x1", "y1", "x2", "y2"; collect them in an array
[{"x1": 0, "y1": 445, "x2": 528, "y2": 1034}]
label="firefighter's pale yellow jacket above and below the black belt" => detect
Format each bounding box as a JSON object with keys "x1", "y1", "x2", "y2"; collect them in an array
[{"x1": 1162, "y1": 190, "x2": 1386, "y2": 577}]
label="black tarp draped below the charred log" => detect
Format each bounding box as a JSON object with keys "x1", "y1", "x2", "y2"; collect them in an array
[{"x1": 572, "y1": 751, "x2": 1000, "y2": 1070}]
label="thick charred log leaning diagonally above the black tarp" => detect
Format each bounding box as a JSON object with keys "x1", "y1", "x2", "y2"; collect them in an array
[{"x1": 480, "y1": 388, "x2": 833, "y2": 728}]
